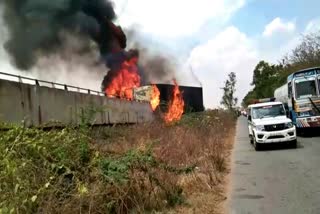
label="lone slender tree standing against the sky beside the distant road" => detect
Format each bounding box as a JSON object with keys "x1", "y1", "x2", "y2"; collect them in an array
[{"x1": 220, "y1": 72, "x2": 238, "y2": 111}]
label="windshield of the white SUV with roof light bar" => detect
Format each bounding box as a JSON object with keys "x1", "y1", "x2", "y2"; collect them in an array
[{"x1": 252, "y1": 104, "x2": 286, "y2": 119}]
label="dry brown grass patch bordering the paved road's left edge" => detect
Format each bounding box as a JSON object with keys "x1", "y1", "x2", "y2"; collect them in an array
[{"x1": 91, "y1": 111, "x2": 235, "y2": 213}]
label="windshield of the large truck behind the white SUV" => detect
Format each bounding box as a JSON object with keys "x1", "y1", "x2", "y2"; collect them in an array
[{"x1": 296, "y1": 80, "x2": 317, "y2": 99}]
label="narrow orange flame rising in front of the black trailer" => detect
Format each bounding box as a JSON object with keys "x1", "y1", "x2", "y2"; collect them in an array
[{"x1": 164, "y1": 80, "x2": 184, "y2": 123}]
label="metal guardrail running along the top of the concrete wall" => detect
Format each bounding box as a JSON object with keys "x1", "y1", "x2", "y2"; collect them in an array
[{"x1": 0, "y1": 72, "x2": 105, "y2": 96}]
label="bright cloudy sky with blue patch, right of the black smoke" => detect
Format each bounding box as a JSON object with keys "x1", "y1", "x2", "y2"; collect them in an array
[{"x1": 115, "y1": 0, "x2": 320, "y2": 108}]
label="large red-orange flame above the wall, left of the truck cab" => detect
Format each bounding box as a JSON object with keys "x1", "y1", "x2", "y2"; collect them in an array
[{"x1": 106, "y1": 57, "x2": 140, "y2": 100}]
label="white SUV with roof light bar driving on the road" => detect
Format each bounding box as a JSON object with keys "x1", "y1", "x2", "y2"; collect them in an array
[{"x1": 247, "y1": 102, "x2": 297, "y2": 151}]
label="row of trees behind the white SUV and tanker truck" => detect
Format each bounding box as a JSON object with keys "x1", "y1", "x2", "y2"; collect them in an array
[{"x1": 242, "y1": 31, "x2": 320, "y2": 107}]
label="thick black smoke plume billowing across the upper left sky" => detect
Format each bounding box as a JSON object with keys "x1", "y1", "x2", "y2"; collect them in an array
[{"x1": 0, "y1": 0, "x2": 126, "y2": 70}]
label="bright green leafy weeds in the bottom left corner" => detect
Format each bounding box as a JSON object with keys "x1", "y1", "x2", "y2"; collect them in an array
[{"x1": 0, "y1": 127, "x2": 89, "y2": 213}]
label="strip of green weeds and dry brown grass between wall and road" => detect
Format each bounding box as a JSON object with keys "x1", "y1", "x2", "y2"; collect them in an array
[{"x1": 0, "y1": 111, "x2": 235, "y2": 213}]
